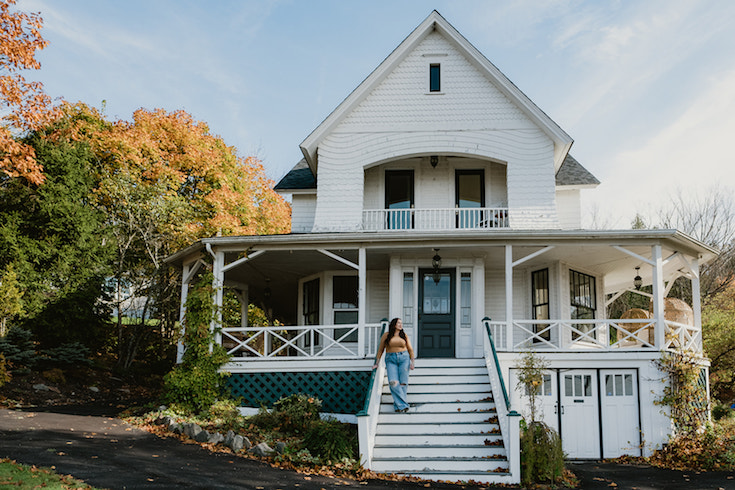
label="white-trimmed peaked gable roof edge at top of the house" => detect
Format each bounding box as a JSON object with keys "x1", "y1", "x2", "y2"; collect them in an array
[{"x1": 300, "y1": 10, "x2": 573, "y2": 174}]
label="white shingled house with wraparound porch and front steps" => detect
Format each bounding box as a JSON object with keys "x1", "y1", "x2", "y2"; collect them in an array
[{"x1": 169, "y1": 11, "x2": 715, "y2": 482}]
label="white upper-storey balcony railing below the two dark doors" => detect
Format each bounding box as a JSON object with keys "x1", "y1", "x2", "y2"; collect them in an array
[{"x1": 362, "y1": 208, "x2": 510, "y2": 231}]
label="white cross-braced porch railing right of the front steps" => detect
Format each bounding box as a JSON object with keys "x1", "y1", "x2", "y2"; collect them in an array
[{"x1": 489, "y1": 319, "x2": 702, "y2": 354}]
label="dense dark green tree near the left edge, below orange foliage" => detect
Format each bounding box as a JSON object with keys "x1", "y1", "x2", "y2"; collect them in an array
[{"x1": 0, "y1": 126, "x2": 112, "y2": 347}]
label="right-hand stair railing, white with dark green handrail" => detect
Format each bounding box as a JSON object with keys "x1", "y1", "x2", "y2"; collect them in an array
[{"x1": 482, "y1": 317, "x2": 521, "y2": 483}]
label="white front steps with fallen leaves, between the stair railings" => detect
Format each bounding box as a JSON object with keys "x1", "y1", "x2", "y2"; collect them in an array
[{"x1": 371, "y1": 359, "x2": 509, "y2": 482}]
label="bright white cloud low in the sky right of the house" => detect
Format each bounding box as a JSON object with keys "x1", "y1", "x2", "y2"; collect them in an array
[{"x1": 585, "y1": 69, "x2": 735, "y2": 227}]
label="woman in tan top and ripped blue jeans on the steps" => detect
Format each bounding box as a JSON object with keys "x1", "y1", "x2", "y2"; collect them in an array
[{"x1": 373, "y1": 318, "x2": 414, "y2": 412}]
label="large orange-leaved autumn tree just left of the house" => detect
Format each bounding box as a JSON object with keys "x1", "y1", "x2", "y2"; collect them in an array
[{"x1": 46, "y1": 104, "x2": 290, "y2": 369}]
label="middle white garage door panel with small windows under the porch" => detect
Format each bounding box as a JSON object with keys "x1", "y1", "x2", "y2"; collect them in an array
[{"x1": 560, "y1": 369, "x2": 600, "y2": 459}]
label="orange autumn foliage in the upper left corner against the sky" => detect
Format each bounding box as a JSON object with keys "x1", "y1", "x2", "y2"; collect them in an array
[{"x1": 0, "y1": 0, "x2": 53, "y2": 184}]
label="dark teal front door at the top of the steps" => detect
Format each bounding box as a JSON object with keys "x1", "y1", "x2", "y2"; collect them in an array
[{"x1": 418, "y1": 269, "x2": 455, "y2": 357}]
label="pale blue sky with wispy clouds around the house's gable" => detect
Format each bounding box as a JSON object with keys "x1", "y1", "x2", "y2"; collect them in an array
[{"x1": 17, "y1": 0, "x2": 735, "y2": 228}]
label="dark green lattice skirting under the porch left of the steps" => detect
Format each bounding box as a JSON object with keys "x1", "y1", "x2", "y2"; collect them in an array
[{"x1": 227, "y1": 371, "x2": 370, "y2": 413}]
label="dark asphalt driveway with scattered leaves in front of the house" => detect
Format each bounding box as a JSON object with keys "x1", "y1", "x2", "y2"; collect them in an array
[{"x1": 0, "y1": 409, "x2": 735, "y2": 490}]
